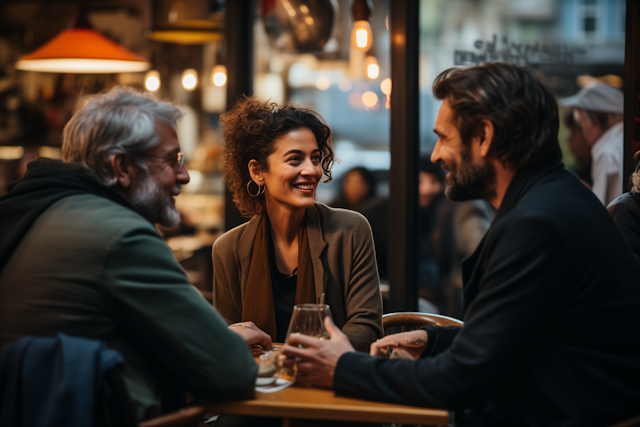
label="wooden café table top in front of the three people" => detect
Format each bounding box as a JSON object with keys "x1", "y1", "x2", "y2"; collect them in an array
[{"x1": 206, "y1": 385, "x2": 449, "y2": 427}]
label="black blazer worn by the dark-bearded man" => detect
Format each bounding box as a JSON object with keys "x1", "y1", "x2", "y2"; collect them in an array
[{"x1": 333, "y1": 164, "x2": 640, "y2": 426}]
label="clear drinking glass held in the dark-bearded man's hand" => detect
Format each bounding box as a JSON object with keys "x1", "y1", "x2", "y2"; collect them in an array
[{"x1": 280, "y1": 304, "x2": 333, "y2": 380}]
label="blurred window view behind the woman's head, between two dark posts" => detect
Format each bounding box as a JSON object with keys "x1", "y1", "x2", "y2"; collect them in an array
[{"x1": 254, "y1": 0, "x2": 390, "y2": 202}]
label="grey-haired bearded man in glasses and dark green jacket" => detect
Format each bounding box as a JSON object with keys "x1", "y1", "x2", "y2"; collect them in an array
[{"x1": 0, "y1": 88, "x2": 270, "y2": 420}]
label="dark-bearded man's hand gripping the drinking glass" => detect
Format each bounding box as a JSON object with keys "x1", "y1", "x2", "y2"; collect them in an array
[{"x1": 282, "y1": 317, "x2": 355, "y2": 387}]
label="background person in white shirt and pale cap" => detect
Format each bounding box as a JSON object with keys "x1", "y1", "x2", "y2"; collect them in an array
[{"x1": 560, "y1": 84, "x2": 624, "y2": 206}]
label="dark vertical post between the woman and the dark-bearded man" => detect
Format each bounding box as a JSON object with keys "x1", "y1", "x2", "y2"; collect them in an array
[{"x1": 389, "y1": 0, "x2": 420, "y2": 311}]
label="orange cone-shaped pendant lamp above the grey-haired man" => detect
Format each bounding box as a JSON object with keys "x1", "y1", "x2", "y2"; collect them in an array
[{"x1": 16, "y1": 12, "x2": 151, "y2": 74}]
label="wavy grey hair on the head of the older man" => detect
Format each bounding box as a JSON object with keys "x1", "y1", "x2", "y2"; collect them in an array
[{"x1": 62, "y1": 86, "x2": 184, "y2": 186}]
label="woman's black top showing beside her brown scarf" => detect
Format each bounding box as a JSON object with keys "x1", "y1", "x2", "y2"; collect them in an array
[{"x1": 268, "y1": 233, "x2": 298, "y2": 342}]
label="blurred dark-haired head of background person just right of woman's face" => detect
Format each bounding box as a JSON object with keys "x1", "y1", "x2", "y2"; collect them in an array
[{"x1": 329, "y1": 166, "x2": 378, "y2": 213}]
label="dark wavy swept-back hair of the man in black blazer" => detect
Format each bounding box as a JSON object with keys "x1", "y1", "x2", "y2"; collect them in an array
[{"x1": 433, "y1": 62, "x2": 562, "y2": 171}]
